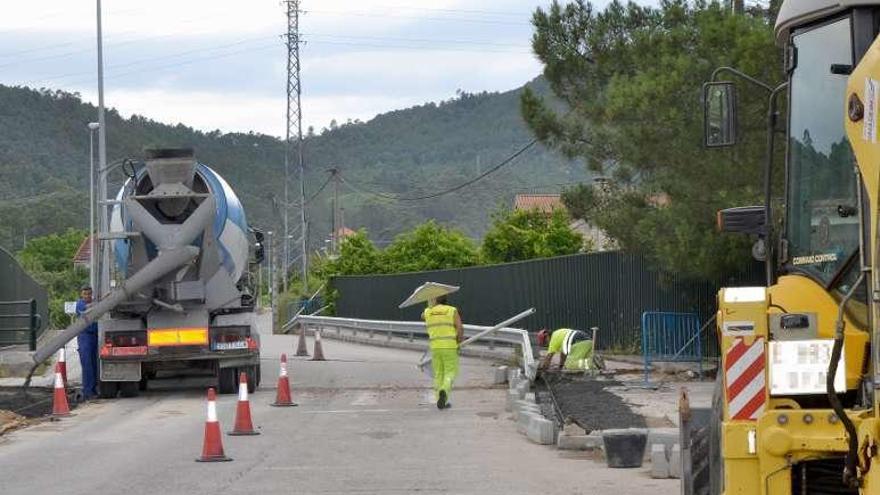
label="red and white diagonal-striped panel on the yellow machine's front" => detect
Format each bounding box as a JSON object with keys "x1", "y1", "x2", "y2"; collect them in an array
[{"x1": 724, "y1": 338, "x2": 767, "y2": 420}]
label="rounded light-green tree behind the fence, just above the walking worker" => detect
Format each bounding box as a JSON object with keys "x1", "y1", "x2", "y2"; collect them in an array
[{"x1": 382, "y1": 220, "x2": 479, "y2": 273}]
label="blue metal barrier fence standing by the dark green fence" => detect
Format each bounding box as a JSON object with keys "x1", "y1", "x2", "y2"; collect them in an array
[{"x1": 642, "y1": 311, "x2": 703, "y2": 385}]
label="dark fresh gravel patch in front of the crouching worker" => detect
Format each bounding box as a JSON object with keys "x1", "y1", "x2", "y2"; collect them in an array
[{"x1": 536, "y1": 374, "x2": 647, "y2": 432}]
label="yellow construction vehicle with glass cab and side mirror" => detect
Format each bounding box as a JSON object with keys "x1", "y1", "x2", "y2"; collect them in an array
[{"x1": 696, "y1": 0, "x2": 880, "y2": 495}]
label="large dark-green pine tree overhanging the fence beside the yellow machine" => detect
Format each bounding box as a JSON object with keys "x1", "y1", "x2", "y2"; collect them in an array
[{"x1": 521, "y1": 0, "x2": 782, "y2": 276}]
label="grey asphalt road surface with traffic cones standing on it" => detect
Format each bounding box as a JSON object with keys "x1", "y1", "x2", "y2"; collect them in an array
[{"x1": 0, "y1": 316, "x2": 679, "y2": 495}]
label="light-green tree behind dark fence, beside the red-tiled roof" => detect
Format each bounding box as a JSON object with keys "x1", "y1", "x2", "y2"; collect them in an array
[{"x1": 482, "y1": 210, "x2": 584, "y2": 263}]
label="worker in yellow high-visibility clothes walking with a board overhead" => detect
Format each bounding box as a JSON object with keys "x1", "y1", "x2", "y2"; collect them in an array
[{"x1": 422, "y1": 296, "x2": 464, "y2": 409}]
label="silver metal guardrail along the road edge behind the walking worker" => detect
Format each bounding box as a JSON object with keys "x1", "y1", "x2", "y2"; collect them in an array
[{"x1": 294, "y1": 316, "x2": 537, "y2": 380}]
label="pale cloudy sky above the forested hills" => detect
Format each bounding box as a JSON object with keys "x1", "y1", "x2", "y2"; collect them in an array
[{"x1": 0, "y1": 0, "x2": 564, "y2": 136}]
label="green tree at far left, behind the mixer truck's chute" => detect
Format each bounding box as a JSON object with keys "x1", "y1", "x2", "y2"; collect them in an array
[{"x1": 18, "y1": 229, "x2": 88, "y2": 328}]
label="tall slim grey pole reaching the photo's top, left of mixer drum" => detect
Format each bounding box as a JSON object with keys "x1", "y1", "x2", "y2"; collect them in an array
[{"x1": 96, "y1": 0, "x2": 110, "y2": 297}]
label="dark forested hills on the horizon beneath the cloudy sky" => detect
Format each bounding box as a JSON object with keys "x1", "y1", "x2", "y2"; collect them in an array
[{"x1": 0, "y1": 81, "x2": 586, "y2": 250}]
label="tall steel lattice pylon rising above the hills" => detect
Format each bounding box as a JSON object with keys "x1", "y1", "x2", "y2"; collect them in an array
[{"x1": 284, "y1": 0, "x2": 309, "y2": 292}]
